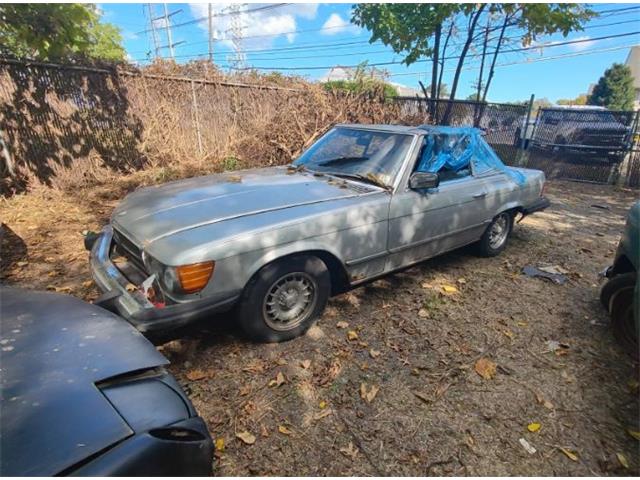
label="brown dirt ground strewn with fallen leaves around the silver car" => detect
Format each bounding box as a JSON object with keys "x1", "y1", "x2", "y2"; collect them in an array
[{"x1": 0, "y1": 182, "x2": 640, "y2": 476}]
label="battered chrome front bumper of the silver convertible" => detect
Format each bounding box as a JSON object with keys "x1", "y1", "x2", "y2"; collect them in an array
[{"x1": 89, "y1": 225, "x2": 239, "y2": 332}]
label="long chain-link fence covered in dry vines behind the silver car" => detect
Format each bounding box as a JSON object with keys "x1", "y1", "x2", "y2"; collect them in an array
[{"x1": 0, "y1": 59, "x2": 640, "y2": 193}]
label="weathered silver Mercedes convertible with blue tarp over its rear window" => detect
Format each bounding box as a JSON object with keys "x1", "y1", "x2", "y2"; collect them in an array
[{"x1": 85, "y1": 125, "x2": 549, "y2": 342}]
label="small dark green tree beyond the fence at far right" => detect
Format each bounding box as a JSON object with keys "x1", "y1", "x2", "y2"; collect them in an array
[{"x1": 587, "y1": 63, "x2": 634, "y2": 110}]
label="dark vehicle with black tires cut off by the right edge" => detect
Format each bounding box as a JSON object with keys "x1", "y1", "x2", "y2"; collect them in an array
[{"x1": 600, "y1": 201, "x2": 640, "y2": 356}]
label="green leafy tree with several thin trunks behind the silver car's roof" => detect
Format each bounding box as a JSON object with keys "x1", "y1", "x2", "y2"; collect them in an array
[{"x1": 351, "y1": 3, "x2": 596, "y2": 123}]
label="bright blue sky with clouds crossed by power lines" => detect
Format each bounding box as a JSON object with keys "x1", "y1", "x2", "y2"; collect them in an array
[{"x1": 99, "y1": 3, "x2": 640, "y2": 102}]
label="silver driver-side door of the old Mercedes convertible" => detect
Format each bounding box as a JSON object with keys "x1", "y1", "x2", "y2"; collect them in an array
[{"x1": 386, "y1": 136, "x2": 488, "y2": 270}]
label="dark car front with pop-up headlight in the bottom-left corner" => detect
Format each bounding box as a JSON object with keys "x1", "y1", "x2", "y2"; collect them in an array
[{"x1": 0, "y1": 287, "x2": 213, "y2": 477}]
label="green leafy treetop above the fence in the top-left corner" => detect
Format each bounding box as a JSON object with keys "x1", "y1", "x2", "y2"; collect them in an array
[{"x1": 0, "y1": 3, "x2": 125, "y2": 61}]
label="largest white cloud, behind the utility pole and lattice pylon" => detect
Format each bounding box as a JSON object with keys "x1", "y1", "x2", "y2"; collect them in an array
[{"x1": 189, "y1": 3, "x2": 318, "y2": 50}]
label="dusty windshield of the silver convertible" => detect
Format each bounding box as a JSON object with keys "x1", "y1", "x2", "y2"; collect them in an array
[{"x1": 294, "y1": 127, "x2": 413, "y2": 186}]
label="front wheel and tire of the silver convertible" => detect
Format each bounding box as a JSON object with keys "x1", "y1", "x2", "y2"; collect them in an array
[{"x1": 237, "y1": 255, "x2": 331, "y2": 342}]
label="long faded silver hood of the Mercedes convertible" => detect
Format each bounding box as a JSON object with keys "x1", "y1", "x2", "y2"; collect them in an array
[{"x1": 112, "y1": 167, "x2": 376, "y2": 247}]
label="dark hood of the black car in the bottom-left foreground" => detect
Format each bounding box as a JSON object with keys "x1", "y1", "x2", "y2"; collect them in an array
[{"x1": 0, "y1": 287, "x2": 168, "y2": 476}]
